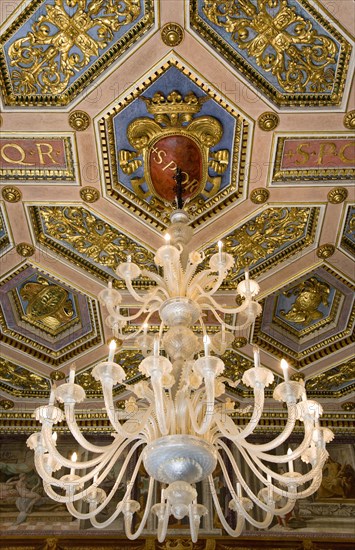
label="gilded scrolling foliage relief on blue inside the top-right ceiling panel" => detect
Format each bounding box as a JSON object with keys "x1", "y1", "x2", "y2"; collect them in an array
[{"x1": 203, "y1": 0, "x2": 338, "y2": 93}]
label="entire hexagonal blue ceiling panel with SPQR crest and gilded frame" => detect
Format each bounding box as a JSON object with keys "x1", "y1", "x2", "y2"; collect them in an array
[{"x1": 99, "y1": 60, "x2": 252, "y2": 228}]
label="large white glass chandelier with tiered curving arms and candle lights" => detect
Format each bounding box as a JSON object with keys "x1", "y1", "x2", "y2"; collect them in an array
[{"x1": 28, "y1": 206, "x2": 333, "y2": 542}]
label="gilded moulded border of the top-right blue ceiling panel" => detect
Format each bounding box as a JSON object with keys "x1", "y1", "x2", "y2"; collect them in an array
[{"x1": 190, "y1": 0, "x2": 352, "y2": 107}]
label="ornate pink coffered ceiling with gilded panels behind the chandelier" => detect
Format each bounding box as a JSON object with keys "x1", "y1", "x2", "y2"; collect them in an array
[{"x1": 0, "y1": 0, "x2": 355, "y2": 429}]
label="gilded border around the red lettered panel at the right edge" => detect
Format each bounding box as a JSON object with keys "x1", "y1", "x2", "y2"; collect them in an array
[{"x1": 270, "y1": 133, "x2": 355, "y2": 185}]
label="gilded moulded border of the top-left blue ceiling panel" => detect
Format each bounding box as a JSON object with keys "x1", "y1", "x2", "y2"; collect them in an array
[{"x1": 0, "y1": 0, "x2": 155, "y2": 107}]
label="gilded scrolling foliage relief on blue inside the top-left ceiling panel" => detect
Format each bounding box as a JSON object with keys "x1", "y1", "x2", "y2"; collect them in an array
[{"x1": 9, "y1": 0, "x2": 141, "y2": 94}]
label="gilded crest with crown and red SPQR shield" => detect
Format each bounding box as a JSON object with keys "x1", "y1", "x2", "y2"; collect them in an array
[{"x1": 119, "y1": 90, "x2": 230, "y2": 209}]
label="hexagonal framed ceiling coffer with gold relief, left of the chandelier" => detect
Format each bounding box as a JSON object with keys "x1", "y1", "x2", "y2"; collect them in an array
[{"x1": 0, "y1": 264, "x2": 102, "y2": 367}]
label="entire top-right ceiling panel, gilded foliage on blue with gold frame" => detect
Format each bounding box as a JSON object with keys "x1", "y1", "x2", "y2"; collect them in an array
[{"x1": 189, "y1": 0, "x2": 352, "y2": 107}]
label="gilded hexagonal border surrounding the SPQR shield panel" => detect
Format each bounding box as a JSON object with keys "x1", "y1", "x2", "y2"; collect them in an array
[{"x1": 98, "y1": 59, "x2": 251, "y2": 230}]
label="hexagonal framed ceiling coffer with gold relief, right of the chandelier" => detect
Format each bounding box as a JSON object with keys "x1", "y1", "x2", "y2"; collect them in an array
[{"x1": 253, "y1": 266, "x2": 355, "y2": 368}]
